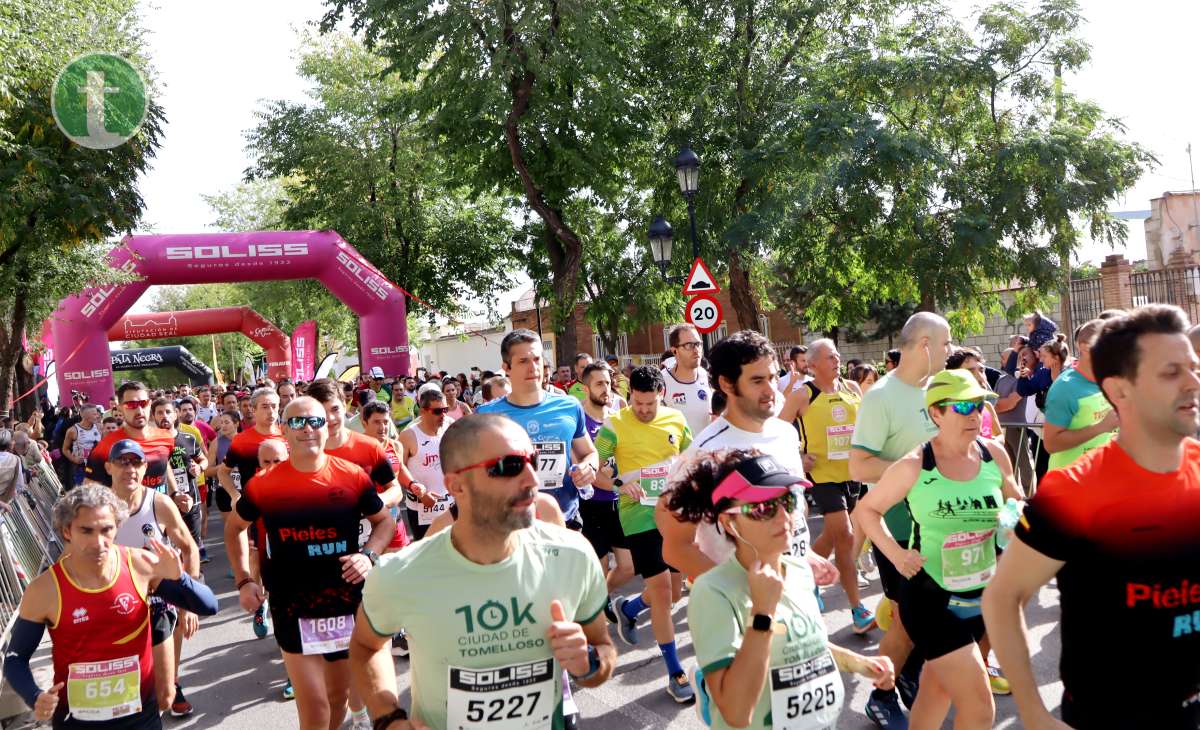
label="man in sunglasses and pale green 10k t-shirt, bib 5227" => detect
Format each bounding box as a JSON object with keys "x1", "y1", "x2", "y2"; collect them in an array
[{"x1": 350, "y1": 413, "x2": 617, "y2": 730}]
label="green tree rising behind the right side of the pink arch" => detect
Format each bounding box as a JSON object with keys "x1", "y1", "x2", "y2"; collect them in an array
[{"x1": 247, "y1": 34, "x2": 518, "y2": 321}]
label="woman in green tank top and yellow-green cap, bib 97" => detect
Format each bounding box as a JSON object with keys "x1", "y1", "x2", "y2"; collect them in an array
[{"x1": 858, "y1": 370, "x2": 1024, "y2": 730}]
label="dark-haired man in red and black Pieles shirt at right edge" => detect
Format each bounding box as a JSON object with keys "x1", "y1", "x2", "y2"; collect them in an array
[{"x1": 984, "y1": 305, "x2": 1200, "y2": 730}]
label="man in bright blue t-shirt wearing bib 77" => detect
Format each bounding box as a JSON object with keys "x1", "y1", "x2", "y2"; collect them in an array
[{"x1": 479, "y1": 329, "x2": 599, "y2": 521}]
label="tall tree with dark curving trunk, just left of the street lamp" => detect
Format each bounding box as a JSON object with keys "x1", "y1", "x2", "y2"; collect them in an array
[{"x1": 322, "y1": 0, "x2": 664, "y2": 363}]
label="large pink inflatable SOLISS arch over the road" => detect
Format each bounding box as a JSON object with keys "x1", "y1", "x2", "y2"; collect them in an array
[{"x1": 50, "y1": 231, "x2": 409, "y2": 403}]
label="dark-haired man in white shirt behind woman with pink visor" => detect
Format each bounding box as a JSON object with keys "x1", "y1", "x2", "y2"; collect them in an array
[{"x1": 654, "y1": 330, "x2": 838, "y2": 585}]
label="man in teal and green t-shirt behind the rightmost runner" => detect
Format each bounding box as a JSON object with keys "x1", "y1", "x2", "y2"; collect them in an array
[{"x1": 1042, "y1": 319, "x2": 1117, "y2": 469}]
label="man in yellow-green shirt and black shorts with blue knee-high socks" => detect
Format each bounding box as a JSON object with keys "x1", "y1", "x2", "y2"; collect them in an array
[{"x1": 595, "y1": 365, "x2": 696, "y2": 704}]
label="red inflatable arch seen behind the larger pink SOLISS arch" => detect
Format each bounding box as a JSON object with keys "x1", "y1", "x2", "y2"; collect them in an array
[{"x1": 108, "y1": 306, "x2": 292, "y2": 381}]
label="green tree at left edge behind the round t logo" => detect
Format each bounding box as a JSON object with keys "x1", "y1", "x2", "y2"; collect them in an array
[{"x1": 0, "y1": 0, "x2": 163, "y2": 411}]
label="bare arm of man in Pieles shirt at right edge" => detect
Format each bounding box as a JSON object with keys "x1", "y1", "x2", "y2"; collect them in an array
[{"x1": 983, "y1": 538, "x2": 1066, "y2": 728}]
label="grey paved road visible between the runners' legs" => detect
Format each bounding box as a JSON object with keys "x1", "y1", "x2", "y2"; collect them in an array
[{"x1": 23, "y1": 515, "x2": 1062, "y2": 730}]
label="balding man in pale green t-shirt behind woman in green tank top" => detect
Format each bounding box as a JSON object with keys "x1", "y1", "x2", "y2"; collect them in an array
[{"x1": 850, "y1": 312, "x2": 950, "y2": 728}]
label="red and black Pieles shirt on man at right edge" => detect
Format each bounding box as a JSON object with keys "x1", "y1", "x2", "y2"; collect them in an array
[{"x1": 1016, "y1": 438, "x2": 1200, "y2": 729}]
